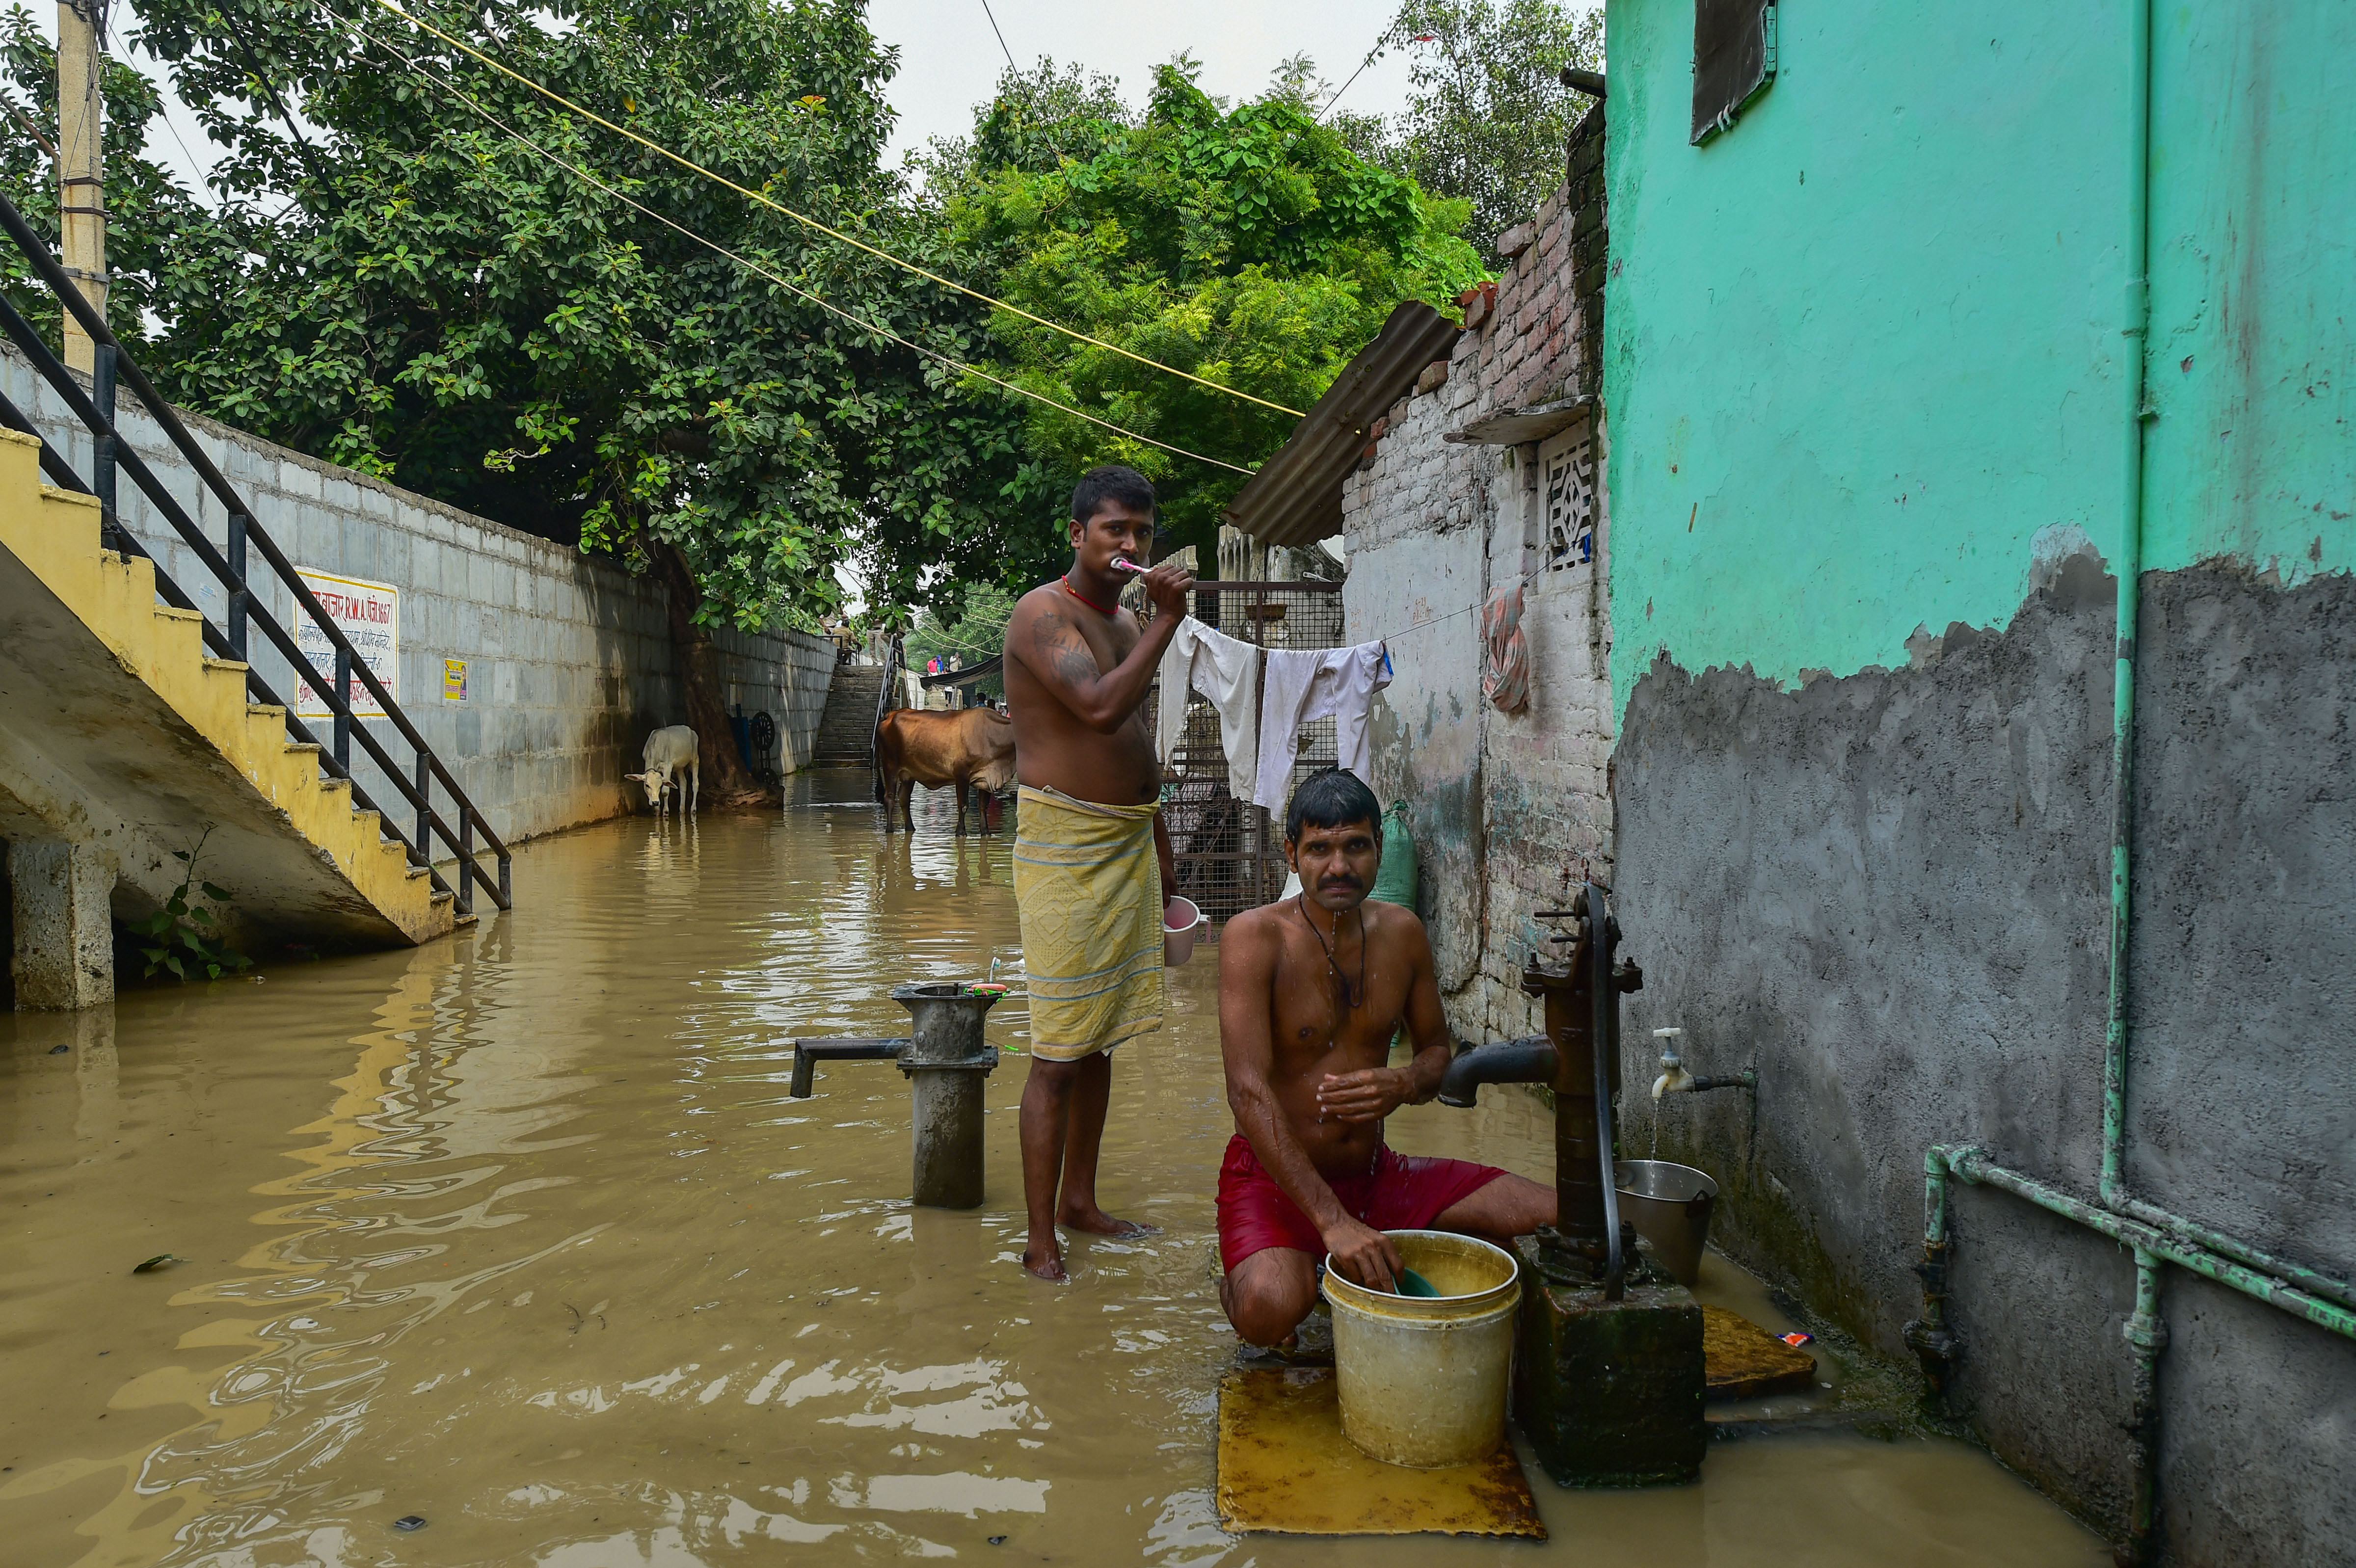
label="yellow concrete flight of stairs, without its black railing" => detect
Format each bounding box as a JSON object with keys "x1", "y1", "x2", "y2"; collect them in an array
[{"x1": 0, "y1": 431, "x2": 455, "y2": 949}]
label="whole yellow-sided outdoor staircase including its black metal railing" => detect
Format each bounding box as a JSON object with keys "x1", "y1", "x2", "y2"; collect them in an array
[{"x1": 0, "y1": 195, "x2": 513, "y2": 1008}]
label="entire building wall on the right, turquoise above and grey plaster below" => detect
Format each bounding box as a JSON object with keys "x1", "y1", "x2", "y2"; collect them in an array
[{"x1": 1605, "y1": 0, "x2": 2356, "y2": 1568}]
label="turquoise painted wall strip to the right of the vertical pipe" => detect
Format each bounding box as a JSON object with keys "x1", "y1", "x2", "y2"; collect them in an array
[{"x1": 2144, "y1": 0, "x2": 2356, "y2": 582}]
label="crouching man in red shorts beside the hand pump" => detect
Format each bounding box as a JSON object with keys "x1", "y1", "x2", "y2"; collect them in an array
[{"x1": 1218, "y1": 768, "x2": 1555, "y2": 1344}]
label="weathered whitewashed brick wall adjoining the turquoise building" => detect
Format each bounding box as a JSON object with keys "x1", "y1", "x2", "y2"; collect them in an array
[{"x1": 1343, "y1": 125, "x2": 1614, "y2": 1038}]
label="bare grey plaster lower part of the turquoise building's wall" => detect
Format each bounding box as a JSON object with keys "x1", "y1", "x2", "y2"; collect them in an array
[{"x1": 1614, "y1": 551, "x2": 2356, "y2": 1566}]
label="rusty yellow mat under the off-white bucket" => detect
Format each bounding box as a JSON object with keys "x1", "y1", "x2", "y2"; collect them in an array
[{"x1": 1218, "y1": 1368, "x2": 1546, "y2": 1540}]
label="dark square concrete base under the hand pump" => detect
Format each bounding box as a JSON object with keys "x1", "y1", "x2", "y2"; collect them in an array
[{"x1": 1513, "y1": 1236, "x2": 1708, "y2": 1486}]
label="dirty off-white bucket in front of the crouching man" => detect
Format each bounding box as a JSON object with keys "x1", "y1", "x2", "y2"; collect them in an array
[{"x1": 1324, "y1": 1231, "x2": 1522, "y2": 1469}]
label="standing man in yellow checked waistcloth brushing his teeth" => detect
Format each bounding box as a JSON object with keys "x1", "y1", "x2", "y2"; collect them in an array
[{"x1": 1006, "y1": 469, "x2": 1195, "y2": 1281}]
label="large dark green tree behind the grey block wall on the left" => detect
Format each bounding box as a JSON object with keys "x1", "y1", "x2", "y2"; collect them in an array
[{"x1": 9, "y1": 0, "x2": 1046, "y2": 794}]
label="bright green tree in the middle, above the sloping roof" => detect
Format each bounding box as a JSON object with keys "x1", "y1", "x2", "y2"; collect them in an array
[{"x1": 926, "y1": 59, "x2": 1484, "y2": 567}]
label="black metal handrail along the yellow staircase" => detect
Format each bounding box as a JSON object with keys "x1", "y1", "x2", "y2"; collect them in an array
[{"x1": 0, "y1": 195, "x2": 513, "y2": 913}]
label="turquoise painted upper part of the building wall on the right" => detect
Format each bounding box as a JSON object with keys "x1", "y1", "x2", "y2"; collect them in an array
[{"x1": 1605, "y1": 0, "x2": 2356, "y2": 706}]
